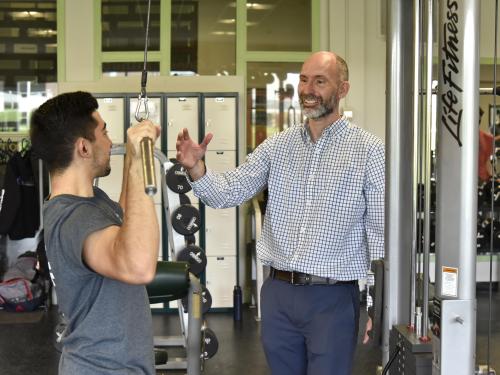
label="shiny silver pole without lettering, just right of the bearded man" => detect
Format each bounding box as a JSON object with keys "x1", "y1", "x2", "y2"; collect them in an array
[{"x1": 382, "y1": 0, "x2": 414, "y2": 363}]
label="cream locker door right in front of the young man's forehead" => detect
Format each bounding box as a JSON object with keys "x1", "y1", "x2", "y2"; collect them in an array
[{"x1": 97, "y1": 98, "x2": 125, "y2": 143}]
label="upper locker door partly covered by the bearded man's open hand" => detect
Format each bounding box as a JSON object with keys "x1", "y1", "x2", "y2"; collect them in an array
[{"x1": 168, "y1": 97, "x2": 199, "y2": 151}]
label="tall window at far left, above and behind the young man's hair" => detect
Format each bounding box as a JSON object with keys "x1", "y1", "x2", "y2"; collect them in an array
[{"x1": 0, "y1": 0, "x2": 57, "y2": 133}]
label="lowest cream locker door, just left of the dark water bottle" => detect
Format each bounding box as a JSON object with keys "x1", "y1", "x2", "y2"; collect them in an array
[{"x1": 206, "y1": 256, "x2": 236, "y2": 308}]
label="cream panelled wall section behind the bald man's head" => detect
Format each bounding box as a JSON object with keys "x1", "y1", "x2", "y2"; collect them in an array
[{"x1": 321, "y1": 0, "x2": 386, "y2": 140}]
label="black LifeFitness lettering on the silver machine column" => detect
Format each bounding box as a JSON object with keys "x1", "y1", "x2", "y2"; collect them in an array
[{"x1": 441, "y1": 0, "x2": 463, "y2": 147}]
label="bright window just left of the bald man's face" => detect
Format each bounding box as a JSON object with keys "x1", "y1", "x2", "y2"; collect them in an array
[{"x1": 247, "y1": 63, "x2": 303, "y2": 151}]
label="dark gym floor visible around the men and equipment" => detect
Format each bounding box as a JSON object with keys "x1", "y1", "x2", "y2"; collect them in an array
[{"x1": 0, "y1": 289, "x2": 500, "y2": 375}]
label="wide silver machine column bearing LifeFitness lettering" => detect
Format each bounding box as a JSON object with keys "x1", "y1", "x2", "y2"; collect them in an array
[{"x1": 433, "y1": 0, "x2": 480, "y2": 375}]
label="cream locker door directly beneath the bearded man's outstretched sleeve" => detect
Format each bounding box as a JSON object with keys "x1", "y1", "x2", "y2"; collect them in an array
[{"x1": 205, "y1": 207, "x2": 237, "y2": 256}]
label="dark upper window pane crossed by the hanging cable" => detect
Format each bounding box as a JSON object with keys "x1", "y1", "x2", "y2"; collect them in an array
[{"x1": 101, "y1": 0, "x2": 160, "y2": 52}]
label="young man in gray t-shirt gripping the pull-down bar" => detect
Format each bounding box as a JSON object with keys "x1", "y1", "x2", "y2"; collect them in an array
[{"x1": 30, "y1": 92, "x2": 160, "y2": 375}]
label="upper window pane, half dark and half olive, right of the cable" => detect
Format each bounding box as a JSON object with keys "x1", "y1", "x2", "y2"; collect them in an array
[{"x1": 171, "y1": 0, "x2": 236, "y2": 75}]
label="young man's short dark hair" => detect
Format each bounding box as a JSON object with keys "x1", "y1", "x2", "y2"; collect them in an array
[{"x1": 30, "y1": 91, "x2": 99, "y2": 173}]
